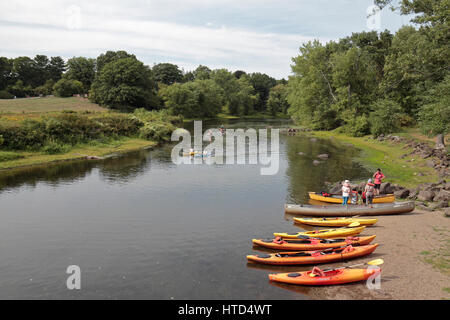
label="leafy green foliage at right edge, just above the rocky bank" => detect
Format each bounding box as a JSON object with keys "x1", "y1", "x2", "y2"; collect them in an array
[{"x1": 419, "y1": 75, "x2": 450, "y2": 136}]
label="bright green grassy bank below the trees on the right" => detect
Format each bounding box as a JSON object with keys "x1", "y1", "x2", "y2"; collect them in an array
[{"x1": 311, "y1": 130, "x2": 439, "y2": 187}]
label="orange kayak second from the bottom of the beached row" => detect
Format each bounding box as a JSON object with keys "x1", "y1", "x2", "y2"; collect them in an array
[{"x1": 247, "y1": 243, "x2": 378, "y2": 265}]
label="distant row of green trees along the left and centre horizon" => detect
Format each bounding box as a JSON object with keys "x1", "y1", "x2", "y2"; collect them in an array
[{"x1": 0, "y1": 51, "x2": 287, "y2": 117}]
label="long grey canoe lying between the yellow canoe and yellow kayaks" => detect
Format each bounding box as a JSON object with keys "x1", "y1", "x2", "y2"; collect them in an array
[{"x1": 284, "y1": 201, "x2": 415, "y2": 217}]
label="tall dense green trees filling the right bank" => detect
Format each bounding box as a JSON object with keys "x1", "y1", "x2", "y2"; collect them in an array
[{"x1": 287, "y1": 0, "x2": 450, "y2": 136}]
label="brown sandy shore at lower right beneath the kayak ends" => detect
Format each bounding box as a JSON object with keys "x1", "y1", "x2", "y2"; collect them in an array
[{"x1": 278, "y1": 209, "x2": 450, "y2": 300}]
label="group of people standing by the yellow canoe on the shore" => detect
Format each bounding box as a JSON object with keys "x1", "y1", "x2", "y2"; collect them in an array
[{"x1": 342, "y1": 169, "x2": 385, "y2": 206}]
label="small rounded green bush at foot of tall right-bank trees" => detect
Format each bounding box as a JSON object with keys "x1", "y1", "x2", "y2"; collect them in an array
[{"x1": 369, "y1": 99, "x2": 401, "y2": 137}]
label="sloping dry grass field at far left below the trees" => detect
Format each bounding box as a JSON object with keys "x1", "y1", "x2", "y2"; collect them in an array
[{"x1": 0, "y1": 97, "x2": 106, "y2": 113}]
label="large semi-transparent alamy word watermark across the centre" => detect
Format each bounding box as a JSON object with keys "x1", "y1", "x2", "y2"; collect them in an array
[{"x1": 171, "y1": 121, "x2": 280, "y2": 175}]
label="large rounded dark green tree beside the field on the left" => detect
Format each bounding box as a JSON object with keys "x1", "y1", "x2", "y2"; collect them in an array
[{"x1": 90, "y1": 57, "x2": 159, "y2": 109}]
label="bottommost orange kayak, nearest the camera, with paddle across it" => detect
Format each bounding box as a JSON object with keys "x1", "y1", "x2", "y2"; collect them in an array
[{"x1": 269, "y1": 268, "x2": 381, "y2": 286}]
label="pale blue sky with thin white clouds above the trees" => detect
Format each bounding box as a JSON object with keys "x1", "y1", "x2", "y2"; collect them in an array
[{"x1": 0, "y1": 0, "x2": 410, "y2": 79}]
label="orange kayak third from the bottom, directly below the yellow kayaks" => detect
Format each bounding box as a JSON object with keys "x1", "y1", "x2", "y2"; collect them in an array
[{"x1": 252, "y1": 236, "x2": 376, "y2": 251}]
